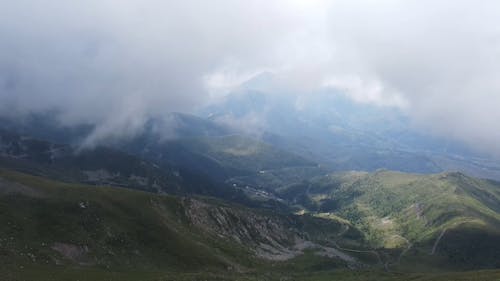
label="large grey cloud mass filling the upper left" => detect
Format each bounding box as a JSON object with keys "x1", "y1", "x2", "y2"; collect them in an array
[{"x1": 0, "y1": 0, "x2": 308, "y2": 130}]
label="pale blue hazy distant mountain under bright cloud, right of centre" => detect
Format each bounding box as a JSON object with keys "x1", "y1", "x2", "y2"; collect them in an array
[{"x1": 198, "y1": 76, "x2": 500, "y2": 179}]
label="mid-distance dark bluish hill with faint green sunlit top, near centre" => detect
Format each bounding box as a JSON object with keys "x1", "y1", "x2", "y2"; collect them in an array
[{"x1": 121, "y1": 135, "x2": 316, "y2": 180}]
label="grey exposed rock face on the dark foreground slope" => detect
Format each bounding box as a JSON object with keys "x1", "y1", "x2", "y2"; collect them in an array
[{"x1": 184, "y1": 199, "x2": 356, "y2": 263}]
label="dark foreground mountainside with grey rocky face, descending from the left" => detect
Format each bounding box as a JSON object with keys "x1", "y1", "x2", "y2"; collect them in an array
[{"x1": 0, "y1": 169, "x2": 500, "y2": 281}]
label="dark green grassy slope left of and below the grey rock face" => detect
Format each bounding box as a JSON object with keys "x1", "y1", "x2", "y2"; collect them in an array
[{"x1": 0, "y1": 168, "x2": 254, "y2": 270}]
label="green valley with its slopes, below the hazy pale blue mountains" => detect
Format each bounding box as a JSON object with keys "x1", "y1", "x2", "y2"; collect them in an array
[{"x1": 0, "y1": 125, "x2": 500, "y2": 280}]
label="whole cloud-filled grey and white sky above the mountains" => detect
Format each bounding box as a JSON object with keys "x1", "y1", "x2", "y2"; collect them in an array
[{"x1": 0, "y1": 0, "x2": 500, "y2": 152}]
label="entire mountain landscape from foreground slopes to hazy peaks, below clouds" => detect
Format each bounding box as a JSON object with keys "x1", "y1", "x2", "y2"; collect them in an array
[{"x1": 0, "y1": 75, "x2": 500, "y2": 280}]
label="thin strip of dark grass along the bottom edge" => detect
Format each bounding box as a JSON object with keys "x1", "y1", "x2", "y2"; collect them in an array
[{"x1": 0, "y1": 266, "x2": 500, "y2": 281}]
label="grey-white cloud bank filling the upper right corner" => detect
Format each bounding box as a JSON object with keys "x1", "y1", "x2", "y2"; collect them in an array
[{"x1": 322, "y1": 1, "x2": 500, "y2": 152}]
